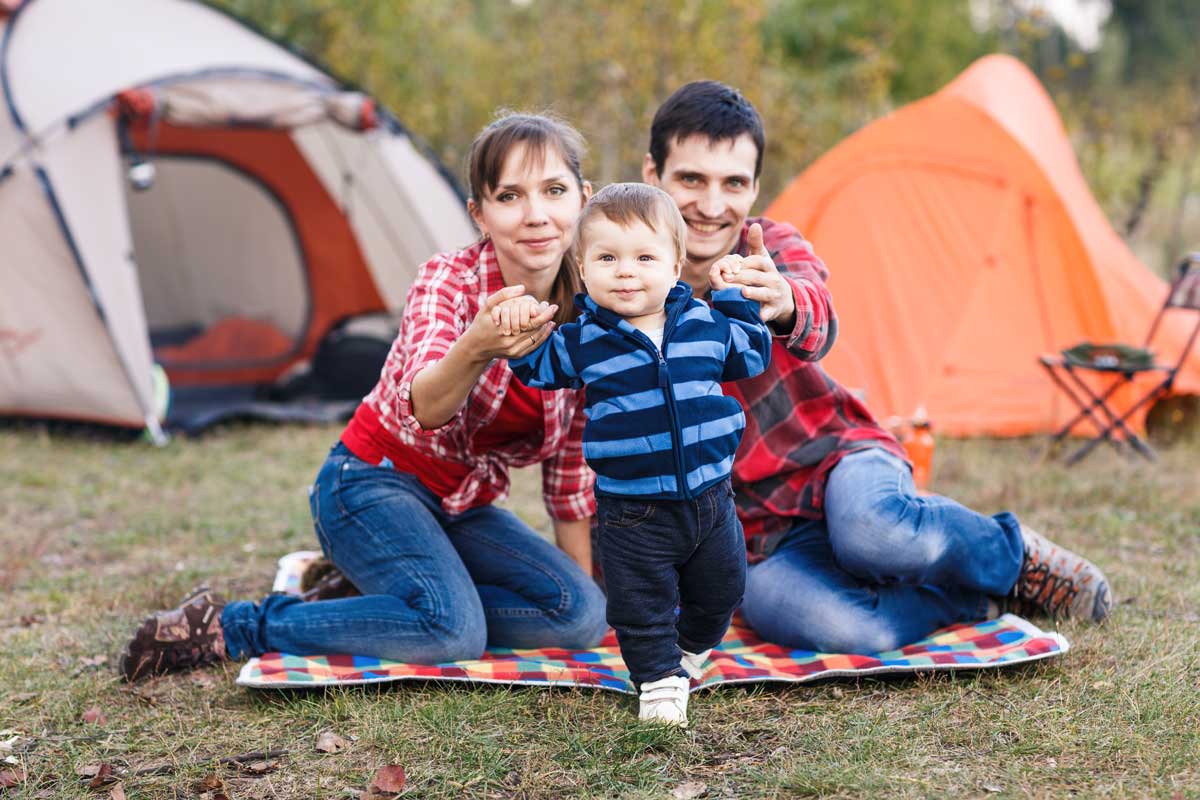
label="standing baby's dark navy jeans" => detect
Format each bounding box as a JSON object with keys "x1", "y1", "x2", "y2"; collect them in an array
[{"x1": 596, "y1": 480, "x2": 746, "y2": 685}]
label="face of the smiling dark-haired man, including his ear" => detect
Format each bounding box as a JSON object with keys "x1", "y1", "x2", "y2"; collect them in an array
[{"x1": 642, "y1": 133, "x2": 758, "y2": 282}]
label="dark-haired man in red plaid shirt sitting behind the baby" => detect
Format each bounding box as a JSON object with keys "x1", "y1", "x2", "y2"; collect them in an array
[{"x1": 642, "y1": 82, "x2": 1112, "y2": 652}]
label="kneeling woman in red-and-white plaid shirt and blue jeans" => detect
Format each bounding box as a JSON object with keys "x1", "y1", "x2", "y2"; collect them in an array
[{"x1": 119, "y1": 115, "x2": 606, "y2": 681}]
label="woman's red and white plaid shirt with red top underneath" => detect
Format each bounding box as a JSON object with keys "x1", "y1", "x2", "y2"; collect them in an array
[{"x1": 342, "y1": 242, "x2": 595, "y2": 521}]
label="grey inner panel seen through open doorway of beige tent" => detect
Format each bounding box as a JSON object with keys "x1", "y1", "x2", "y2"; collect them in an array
[{"x1": 126, "y1": 157, "x2": 310, "y2": 371}]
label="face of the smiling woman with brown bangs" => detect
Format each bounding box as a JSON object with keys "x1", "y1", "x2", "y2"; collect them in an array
[{"x1": 469, "y1": 144, "x2": 587, "y2": 283}]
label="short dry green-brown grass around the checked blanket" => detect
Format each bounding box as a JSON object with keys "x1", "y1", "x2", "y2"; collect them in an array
[{"x1": 0, "y1": 426, "x2": 1200, "y2": 799}]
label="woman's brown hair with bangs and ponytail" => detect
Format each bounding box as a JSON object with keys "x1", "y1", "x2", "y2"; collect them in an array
[{"x1": 467, "y1": 113, "x2": 587, "y2": 325}]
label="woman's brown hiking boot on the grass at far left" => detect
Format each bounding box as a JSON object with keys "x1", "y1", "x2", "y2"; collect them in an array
[{"x1": 116, "y1": 587, "x2": 228, "y2": 682}]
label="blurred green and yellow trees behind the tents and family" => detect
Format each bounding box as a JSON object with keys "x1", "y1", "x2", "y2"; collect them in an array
[{"x1": 212, "y1": 0, "x2": 1200, "y2": 277}]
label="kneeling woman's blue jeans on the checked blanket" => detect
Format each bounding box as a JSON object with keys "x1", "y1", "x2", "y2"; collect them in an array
[{"x1": 221, "y1": 444, "x2": 606, "y2": 664}]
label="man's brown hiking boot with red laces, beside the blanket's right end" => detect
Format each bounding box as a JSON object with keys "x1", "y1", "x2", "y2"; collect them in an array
[{"x1": 1010, "y1": 525, "x2": 1112, "y2": 622}]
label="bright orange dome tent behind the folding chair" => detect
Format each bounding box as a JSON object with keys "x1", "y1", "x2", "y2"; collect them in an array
[{"x1": 766, "y1": 55, "x2": 1200, "y2": 435}]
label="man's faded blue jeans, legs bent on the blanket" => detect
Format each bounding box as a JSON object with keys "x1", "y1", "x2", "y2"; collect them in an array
[{"x1": 742, "y1": 449, "x2": 1024, "y2": 654}]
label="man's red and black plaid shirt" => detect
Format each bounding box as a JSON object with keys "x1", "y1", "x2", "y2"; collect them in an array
[{"x1": 724, "y1": 218, "x2": 907, "y2": 561}]
